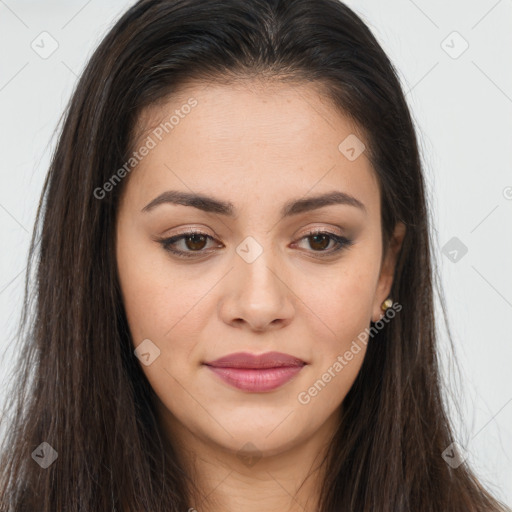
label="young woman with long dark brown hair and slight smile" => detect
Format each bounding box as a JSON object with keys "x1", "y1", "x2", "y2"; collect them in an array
[{"x1": 0, "y1": 0, "x2": 507, "y2": 512}]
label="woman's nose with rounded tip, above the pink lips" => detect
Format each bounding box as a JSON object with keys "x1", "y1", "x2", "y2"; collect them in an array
[{"x1": 219, "y1": 245, "x2": 295, "y2": 332}]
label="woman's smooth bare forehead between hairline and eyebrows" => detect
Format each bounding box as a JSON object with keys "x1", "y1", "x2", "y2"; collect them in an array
[{"x1": 125, "y1": 81, "x2": 379, "y2": 219}]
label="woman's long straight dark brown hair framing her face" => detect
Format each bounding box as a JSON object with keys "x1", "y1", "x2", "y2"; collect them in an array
[{"x1": 0, "y1": 0, "x2": 507, "y2": 512}]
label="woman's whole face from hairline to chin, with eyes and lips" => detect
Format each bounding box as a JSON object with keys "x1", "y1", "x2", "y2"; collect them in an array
[{"x1": 116, "y1": 82, "x2": 403, "y2": 460}]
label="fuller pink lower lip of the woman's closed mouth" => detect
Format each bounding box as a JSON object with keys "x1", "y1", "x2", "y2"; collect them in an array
[{"x1": 206, "y1": 365, "x2": 303, "y2": 393}]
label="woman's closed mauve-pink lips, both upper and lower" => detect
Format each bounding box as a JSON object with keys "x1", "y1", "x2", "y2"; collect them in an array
[{"x1": 204, "y1": 352, "x2": 307, "y2": 393}]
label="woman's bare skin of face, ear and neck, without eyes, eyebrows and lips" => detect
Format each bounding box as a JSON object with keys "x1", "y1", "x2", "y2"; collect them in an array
[{"x1": 116, "y1": 81, "x2": 404, "y2": 512}]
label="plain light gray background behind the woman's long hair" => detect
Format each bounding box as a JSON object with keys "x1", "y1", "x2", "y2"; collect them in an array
[{"x1": 0, "y1": 0, "x2": 512, "y2": 505}]
